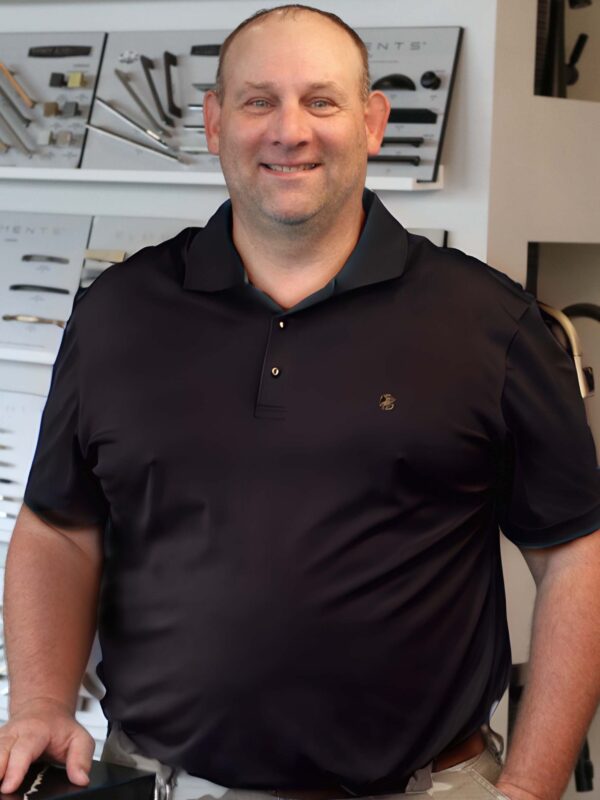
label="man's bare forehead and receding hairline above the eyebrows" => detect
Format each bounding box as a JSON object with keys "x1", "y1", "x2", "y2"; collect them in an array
[{"x1": 223, "y1": 12, "x2": 362, "y2": 85}]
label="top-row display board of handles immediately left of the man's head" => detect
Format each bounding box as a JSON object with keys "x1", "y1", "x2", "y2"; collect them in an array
[{"x1": 82, "y1": 30, "x2": 228, "y2": 173}]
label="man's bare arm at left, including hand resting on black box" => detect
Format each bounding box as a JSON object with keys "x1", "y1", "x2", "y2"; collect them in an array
[{"x1": 0, "y1": 506, "x2": 102, "y2": 793}]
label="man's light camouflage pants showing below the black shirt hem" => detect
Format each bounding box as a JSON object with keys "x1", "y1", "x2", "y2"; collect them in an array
[{"x1": 102, "y1": 724, "x2": 508, "y2": 800}]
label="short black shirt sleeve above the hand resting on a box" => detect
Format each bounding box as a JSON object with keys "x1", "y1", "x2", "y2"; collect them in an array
[{"x1": 24, "y1": 290, "x2": 107, "y2": 528}]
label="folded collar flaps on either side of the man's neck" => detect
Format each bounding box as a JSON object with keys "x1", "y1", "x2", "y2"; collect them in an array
[{"x1": 183, "y1": 189, "x2": 408, "y2": 294}]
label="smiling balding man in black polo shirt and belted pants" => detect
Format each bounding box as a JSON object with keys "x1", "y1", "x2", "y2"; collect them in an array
[{"x1": 0, "y1": 7, "x2": 600, "y2": 800}]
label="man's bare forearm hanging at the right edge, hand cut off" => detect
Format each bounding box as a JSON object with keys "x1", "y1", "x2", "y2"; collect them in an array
[{"x1": 496, "y1": 530, "x2": 600, "y2": 800}]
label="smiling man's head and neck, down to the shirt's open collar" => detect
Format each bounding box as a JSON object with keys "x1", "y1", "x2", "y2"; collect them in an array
[{"x1": 204, "y1": 10, "x2": 389, "y2": 308}]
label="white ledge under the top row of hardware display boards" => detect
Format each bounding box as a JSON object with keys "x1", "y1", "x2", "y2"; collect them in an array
[{"x1": 0, "y1": 167, "x2": 444, "y2": 192}]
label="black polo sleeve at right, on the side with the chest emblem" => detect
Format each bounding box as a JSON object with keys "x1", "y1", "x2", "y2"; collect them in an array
[{"x1": 499, "y1": 302, "x2": 600, "y2": 548}]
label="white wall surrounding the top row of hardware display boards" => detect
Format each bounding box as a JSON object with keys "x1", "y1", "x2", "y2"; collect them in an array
[{"x1": 0, "y1": 0, "x2": 496, "y2": 258}]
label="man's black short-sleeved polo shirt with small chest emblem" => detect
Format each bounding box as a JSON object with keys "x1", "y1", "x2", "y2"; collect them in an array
[{"x1": 25, "y1": 192, "x2": 600, "y2": 794}]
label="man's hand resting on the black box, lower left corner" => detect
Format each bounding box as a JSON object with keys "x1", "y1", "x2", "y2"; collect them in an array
[{"x1": 0, "y1": 698, "x2": 94, "y2": 794}]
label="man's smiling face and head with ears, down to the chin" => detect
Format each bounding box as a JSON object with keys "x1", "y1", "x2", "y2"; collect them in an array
[{"x1": 204, "y1": 12, "x2": 389, "y2": 231}]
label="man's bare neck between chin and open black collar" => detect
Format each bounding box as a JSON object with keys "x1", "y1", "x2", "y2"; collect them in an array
[{"x1": 233, "y1": 198, "x2": 365, "y2": 308}]
